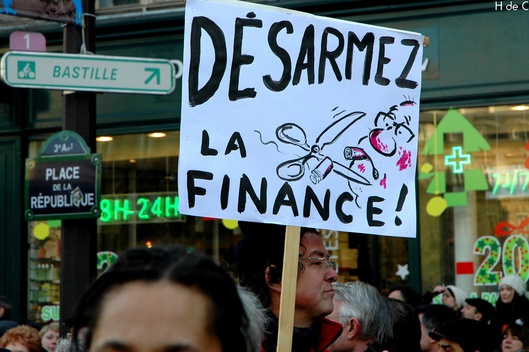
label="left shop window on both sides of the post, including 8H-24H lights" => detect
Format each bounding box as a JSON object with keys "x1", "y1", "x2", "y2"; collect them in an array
[{"x1": 28, "y1": 131, "x2": 241, "y2": 323}]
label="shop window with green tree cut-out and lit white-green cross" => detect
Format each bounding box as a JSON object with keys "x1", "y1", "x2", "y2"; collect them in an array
[{"x1": 416, "y1": 105, "x2": 529, "y2": 302}]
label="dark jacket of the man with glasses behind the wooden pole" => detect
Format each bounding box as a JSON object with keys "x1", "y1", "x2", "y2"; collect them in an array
[{"x1": 261, "y1": 311, "x2": 342, "y2": 352}]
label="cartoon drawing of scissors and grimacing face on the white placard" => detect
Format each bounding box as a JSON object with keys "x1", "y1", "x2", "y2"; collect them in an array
[{"x1": 263, "y1": 100, "x2": 415, "y2": 205}]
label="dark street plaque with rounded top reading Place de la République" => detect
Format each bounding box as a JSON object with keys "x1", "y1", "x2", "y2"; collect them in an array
[{"x1": 25, "y1": 131, "x2": 101, "y2": 221}]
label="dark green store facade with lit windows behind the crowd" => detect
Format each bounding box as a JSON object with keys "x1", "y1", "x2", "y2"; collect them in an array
[{"x1": 0, "y1": 1, "x2": 529, "y2": 322}]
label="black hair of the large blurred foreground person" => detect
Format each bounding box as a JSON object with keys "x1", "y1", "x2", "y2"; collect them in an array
[{"x1": 73, "y1": 246, "x2": 250, "y2": 352}]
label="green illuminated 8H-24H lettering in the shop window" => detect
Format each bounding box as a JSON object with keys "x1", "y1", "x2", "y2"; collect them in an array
[{"x1": 99, "y1": 192, "x2": 185, "y2": 224}]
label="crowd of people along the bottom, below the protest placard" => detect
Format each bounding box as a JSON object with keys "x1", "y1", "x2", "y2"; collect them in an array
[{"x1": 0, "y1": 222, "x2": 529, "y2": 352}]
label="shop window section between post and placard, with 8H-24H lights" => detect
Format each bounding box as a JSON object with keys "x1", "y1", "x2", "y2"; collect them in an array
[{"x1": 97, "y1": 131, "x2": 240, "y2": 270}]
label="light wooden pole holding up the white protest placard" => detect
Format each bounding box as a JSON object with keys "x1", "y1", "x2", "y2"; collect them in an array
[{"x1": 277, "y1": 226, "x2": 301, "y2": 352}]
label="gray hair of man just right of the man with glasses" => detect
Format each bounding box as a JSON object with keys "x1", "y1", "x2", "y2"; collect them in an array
[{"x1": 333, "y1": 281, "x2": 393, "y2": 342}]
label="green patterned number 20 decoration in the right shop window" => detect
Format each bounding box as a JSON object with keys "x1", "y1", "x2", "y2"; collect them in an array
[{"x1": 474, "y1": 235, "x2": 529, "y2": 286}]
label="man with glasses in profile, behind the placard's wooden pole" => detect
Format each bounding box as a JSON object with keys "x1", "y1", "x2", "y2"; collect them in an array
[{"x1": 236, "y1": 221, "x2": 341, "y2": 352}]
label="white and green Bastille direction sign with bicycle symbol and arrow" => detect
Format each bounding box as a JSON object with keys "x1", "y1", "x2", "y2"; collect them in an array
[{"x1": 0, "y1": 51, "x2": 175, "y2": 94}]
